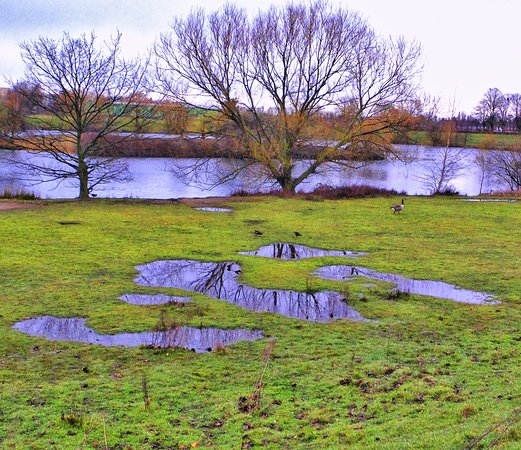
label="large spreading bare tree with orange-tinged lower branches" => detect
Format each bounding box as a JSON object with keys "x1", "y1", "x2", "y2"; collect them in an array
[{"x1": 155, "y1": 0, "x2": 420, "y2": 191}]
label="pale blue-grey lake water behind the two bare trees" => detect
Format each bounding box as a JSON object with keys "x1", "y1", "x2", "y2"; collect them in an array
[{"x1": 0, "y1": 145, "x2": 500, "y2": 199}]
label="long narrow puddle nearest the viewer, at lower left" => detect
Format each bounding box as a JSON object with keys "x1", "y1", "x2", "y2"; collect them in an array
[{"x1": 13, "y1": 316, "x2": 263, "y2": 353}]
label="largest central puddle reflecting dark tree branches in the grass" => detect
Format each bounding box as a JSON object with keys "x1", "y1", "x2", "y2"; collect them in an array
[{"x1": 134, "y1": 260, "x2": 366, "y2": 322}]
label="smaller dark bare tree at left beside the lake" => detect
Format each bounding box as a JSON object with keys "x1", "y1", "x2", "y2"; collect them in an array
[{"x1": 3, "y1": 33, "x2": 150, "y2": 199}]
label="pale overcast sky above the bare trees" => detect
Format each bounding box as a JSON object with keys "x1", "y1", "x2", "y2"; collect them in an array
[{"x1": 0, "y1": 0, "x2": 521, "y2": 113}]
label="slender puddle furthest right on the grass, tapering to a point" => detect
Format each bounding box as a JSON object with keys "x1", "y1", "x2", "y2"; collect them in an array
[{"x1": 314, "y1": 265, "x2": 499, "y2": 305}]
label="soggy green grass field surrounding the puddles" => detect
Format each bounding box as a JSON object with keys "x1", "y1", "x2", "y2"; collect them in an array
[{"x1": 0, "y1": 197, "x2": 521, "y2": 449}]
